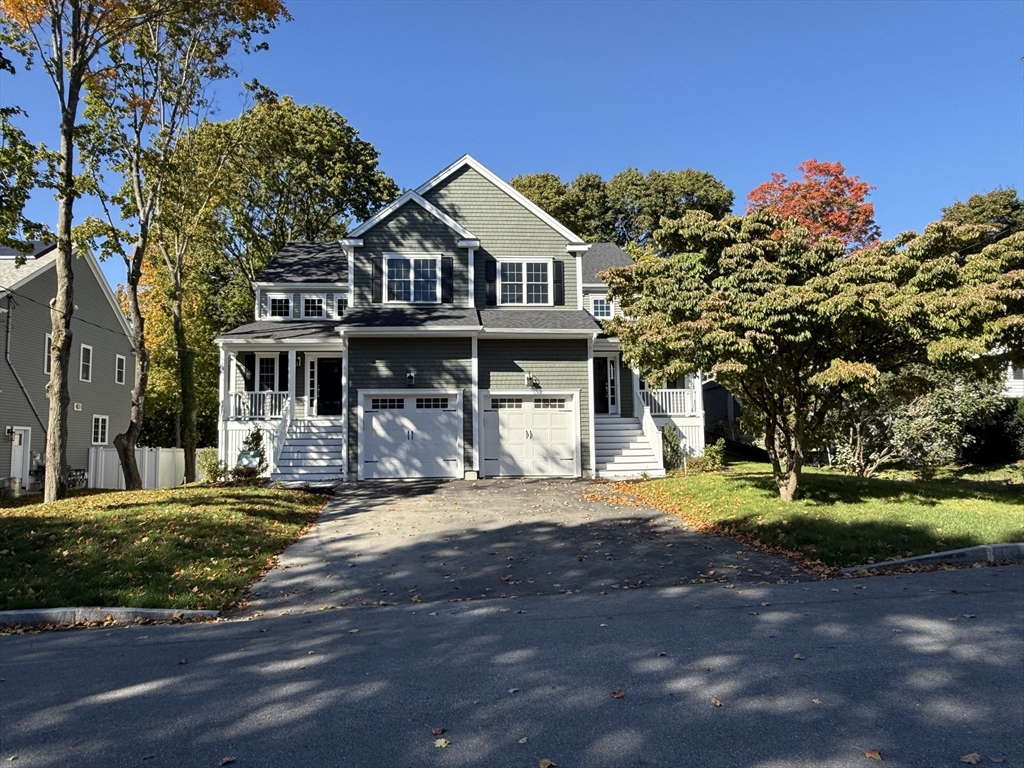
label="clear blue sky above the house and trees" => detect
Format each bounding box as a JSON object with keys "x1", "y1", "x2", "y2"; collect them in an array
[{"x1": 0, "y1": 0, "x2": 1024, "y2": 284}]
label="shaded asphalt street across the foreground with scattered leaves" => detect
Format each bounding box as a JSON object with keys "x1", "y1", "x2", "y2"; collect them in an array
[{"x1": 0, "y1": 565, "x2": 1024, "y2": 768}]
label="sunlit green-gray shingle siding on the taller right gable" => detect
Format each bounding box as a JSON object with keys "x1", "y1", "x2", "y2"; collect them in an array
[{"x1": 424, "y1": 167, "x2": 577, "y2": 310}]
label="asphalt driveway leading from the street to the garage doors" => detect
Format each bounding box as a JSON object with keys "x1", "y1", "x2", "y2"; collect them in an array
[{"x1": 236, "y1": 478, "x2": 813, "y2": 616}]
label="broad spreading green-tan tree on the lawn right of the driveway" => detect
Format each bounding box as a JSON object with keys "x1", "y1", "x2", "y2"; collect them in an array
[{"x1": 606, "y1": 209, "x2": 1024, "y2": 499}]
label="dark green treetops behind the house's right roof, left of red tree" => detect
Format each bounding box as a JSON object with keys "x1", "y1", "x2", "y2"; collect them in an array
[{"x1": 512, "y1": 168, "x2": 733, "y2": 247}]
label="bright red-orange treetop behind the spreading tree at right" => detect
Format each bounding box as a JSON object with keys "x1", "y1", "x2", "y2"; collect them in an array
[{"x1": 746, "y1": 159, "x2": 881, "y2": 250}]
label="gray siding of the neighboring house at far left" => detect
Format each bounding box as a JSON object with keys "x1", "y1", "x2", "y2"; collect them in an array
[{"x1": 0, "y1": 259, "x2": 135, "y2": 477}]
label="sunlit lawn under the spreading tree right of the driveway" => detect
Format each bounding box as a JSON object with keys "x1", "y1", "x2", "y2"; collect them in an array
[{"x1": 620, "y1": 463, "x2": 1024, "y2": 568}]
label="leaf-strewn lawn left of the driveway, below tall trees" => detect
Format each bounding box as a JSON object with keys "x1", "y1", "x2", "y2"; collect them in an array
[{"x1": 0, "y1": 485, "x2": 325, "y2": 610}]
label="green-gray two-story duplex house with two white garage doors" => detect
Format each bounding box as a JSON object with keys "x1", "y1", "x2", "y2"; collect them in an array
[{"x1": 217, "y1": 156, "x2": 704, "y2": 480}]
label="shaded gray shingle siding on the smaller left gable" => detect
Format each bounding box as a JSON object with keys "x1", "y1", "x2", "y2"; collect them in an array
[{"x1": 352, "y1": 208, "x2": 469, "y2": 307}]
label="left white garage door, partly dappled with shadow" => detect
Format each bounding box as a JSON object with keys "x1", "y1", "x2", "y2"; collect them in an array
[{"x1": 359, "y1": 392, "x2": 463, "y2": 479}]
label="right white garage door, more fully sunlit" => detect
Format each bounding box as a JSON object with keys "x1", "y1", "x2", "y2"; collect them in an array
[{"x1": 483, "y1": 394, "x2": 577, "y2": 477}]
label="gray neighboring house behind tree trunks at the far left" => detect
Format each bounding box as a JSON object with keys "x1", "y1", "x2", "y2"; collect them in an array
[{"x1": 0, "y1": 243, "x2": 135, "y2": 487}]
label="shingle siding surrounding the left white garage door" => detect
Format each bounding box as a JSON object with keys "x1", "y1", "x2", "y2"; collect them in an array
[{"x1": 348, "y1": 338, "x2": 473, "y2": 477}]
